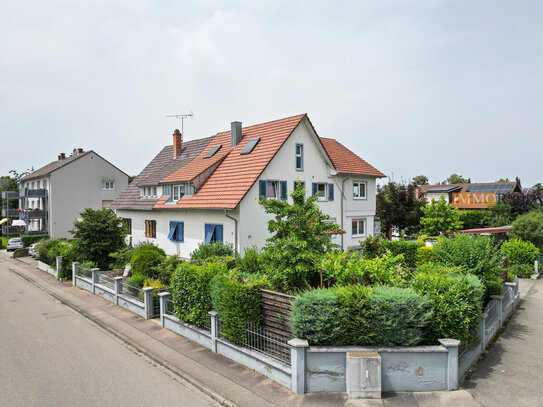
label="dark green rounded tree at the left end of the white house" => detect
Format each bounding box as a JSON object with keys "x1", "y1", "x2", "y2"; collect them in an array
[{"x1": 71, "y1": 208, "x2": 125, "y2": 270}]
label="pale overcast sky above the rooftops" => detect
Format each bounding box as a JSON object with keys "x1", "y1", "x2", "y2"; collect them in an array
[{"x1": 0, "y1": 0, "x2": 543, "y2": 186}]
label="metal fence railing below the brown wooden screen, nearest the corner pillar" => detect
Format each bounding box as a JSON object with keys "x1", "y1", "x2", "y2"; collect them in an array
[{"x1": 219, "y1": 320, "x2": 290, "y2": 366}]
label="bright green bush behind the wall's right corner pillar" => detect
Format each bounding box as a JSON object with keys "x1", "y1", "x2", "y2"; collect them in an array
[{"x1": 409, "y1": 270, "x2": 484, "y2": 346}]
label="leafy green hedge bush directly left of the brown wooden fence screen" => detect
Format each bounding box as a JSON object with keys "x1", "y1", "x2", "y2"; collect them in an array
[{"x1": 211, "y1": 272, "x2": 268, "y2": 344}]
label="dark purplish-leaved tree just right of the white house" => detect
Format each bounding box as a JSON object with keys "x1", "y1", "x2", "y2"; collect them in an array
[{"x1": 376, "y1": 182, "x2": 424, "y2": 235}]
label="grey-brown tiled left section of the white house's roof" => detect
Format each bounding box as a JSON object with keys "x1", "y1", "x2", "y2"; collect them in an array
[{"x1": 111, "y1": 137, "x2": 213, "y2": 210}]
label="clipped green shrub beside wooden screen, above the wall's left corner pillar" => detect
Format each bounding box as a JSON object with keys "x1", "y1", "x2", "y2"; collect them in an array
[{"x1": 289, "y1": 289, "x2": 342, "y2": 345}]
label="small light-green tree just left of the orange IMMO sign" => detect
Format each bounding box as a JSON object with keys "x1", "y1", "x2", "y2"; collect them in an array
[{"x1": 420, "y1": 196, "x2": 462, "y2": 236}]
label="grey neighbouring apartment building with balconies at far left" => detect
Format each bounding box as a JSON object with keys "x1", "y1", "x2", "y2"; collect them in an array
[{"x1": 11, "y1": 148, "x2": 128, "y2": 238}]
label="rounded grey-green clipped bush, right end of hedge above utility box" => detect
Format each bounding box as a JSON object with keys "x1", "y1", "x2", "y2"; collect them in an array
[{"x1": 368, "y1": 287, "x2": 432, "y2": 346}]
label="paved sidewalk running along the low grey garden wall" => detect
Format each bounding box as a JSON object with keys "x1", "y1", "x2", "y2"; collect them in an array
[{"x1": 4, "y1": 251, "x2": 532, "y2": 407}]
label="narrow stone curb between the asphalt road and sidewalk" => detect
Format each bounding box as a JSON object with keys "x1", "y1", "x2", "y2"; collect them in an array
[{"x1": 8, "y1": 259, "x2": 239, "y2": 407}]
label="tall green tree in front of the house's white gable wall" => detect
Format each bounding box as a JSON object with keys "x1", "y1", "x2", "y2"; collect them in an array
[{"x1": 260, "y1": 183, "x2": 340, "y2": 292}]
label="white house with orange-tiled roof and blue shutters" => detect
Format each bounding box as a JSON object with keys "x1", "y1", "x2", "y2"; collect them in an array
[{"x1": 112, "y1": 114, "x2": 384, "y2": 258}]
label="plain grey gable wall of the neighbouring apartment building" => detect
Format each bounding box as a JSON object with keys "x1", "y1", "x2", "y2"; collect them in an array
[{"x1": 48, "y1": 152, "x2": 128, "y2": 238}]
